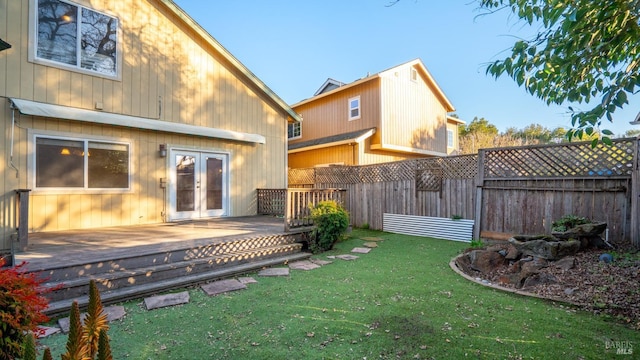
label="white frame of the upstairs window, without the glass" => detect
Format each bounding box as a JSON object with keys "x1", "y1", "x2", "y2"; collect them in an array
[{"x1": 28, "y1": 0, "x2": 123, "y2": 80}]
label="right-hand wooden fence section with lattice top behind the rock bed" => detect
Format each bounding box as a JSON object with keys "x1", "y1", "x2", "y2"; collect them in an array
[{"x1": 475, "y1": 139, "x2": 640, "y2": 245}]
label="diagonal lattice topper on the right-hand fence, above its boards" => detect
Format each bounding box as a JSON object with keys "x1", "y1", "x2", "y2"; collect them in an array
[{"x1": 483, "y1": 139, "x2": 634, "y2": 178}]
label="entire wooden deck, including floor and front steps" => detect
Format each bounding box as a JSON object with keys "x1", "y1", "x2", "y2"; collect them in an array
[{"x1": 9, "y1": 216, "x2": 311, "y2": 314}]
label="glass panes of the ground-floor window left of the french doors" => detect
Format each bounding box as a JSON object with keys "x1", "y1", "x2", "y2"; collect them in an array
[{"x1": 35, "y1": 136, "x2": 130, "y2": 189}]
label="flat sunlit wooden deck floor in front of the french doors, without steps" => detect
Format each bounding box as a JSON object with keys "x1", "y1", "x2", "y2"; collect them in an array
[{"x1": 15, "y1": 216, "x2": 285, "y2": 271}]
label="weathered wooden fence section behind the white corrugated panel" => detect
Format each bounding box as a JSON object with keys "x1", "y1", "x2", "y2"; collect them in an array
[{"x1": 289, "y1": 155, "x2": 478, "y2": 230}]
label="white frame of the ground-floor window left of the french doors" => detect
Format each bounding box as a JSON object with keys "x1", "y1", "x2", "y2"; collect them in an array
[{"x1": 28, "y1": 130, "x2": 135, "y2": 194}]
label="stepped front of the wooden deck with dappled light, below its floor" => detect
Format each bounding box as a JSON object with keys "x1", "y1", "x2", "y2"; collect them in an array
[{"x1": 30, "y1": 229, "x2": 311, "y2": 315}]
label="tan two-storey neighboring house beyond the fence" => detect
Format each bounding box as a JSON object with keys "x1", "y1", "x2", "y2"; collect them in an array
[{"x1": 288, "y1": 60, "x2": 464, "y2": 168}]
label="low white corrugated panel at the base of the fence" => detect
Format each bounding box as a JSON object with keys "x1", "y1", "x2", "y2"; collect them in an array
[{"x1": 382, "y1": 213, "x2": 474, "y2": 242}]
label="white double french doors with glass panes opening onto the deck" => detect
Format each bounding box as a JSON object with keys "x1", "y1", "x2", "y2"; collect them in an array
[{"x1": 169, "y1": 150, "x2": 229, "y2": 221}]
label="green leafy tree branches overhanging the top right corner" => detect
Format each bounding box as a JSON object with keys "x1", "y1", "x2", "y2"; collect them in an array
[{"x1": 479, "y1": 0, "x2": 640, "y2": 145}]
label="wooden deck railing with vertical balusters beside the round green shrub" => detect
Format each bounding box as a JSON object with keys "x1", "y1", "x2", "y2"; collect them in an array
[{"x1": 257, "y1": 189, "x2": 348, "y2": 231}]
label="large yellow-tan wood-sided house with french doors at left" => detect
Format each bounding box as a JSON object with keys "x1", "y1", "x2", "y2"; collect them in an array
[{"x1": 0, "y1": 0, "x2": 300, "y2": 250}]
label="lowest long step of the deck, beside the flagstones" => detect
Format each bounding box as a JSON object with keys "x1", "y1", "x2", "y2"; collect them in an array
[{"x1": 45, "y1": 252, "x2": 311, "y2": 316}]
